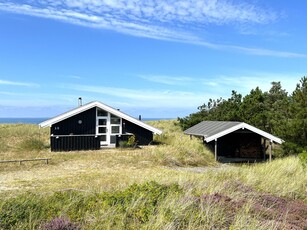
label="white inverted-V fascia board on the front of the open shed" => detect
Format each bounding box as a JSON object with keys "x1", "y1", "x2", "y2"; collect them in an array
[{"x1": 205, "y1": 122, "x2": 284, "y2": 144}]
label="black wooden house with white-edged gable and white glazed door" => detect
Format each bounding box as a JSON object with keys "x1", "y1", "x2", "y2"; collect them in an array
[{"x1": 39, "y1": 101, "x2": 162, "y2": 151}]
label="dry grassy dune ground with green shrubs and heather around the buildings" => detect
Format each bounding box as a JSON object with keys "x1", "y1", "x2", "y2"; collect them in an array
[{"x1": 0, "y1": 121, "x2": 307, "y2": 229}]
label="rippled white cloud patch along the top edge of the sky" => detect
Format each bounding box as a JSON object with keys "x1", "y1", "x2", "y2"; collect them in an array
[{"x1": 0, "y1": 0, "x2": 277, "y2": 26}]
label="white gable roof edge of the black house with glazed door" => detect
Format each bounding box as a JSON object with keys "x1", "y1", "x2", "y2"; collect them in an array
[{"x1": 39, "y1": 101, "x2": 162, "y2": 134}]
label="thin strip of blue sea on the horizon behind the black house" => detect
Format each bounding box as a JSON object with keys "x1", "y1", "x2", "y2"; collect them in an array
[{"x1": 0, "y1": 117, "x2": 173, "y2": 125}]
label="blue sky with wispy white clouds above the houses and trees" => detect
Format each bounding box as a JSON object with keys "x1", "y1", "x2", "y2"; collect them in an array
[{"x1": 0, "y1": 0, "x2": 307, "y2": 118}]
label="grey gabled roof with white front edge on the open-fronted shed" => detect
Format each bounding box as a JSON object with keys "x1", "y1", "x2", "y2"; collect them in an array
[{"x1": 184, "y1": 121, "x2": 284, "y2": 144}]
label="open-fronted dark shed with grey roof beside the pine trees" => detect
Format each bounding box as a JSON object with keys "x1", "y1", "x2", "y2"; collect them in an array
[{"x1": 184, "y1": 121, "x2": 283, "y2": 162}]
